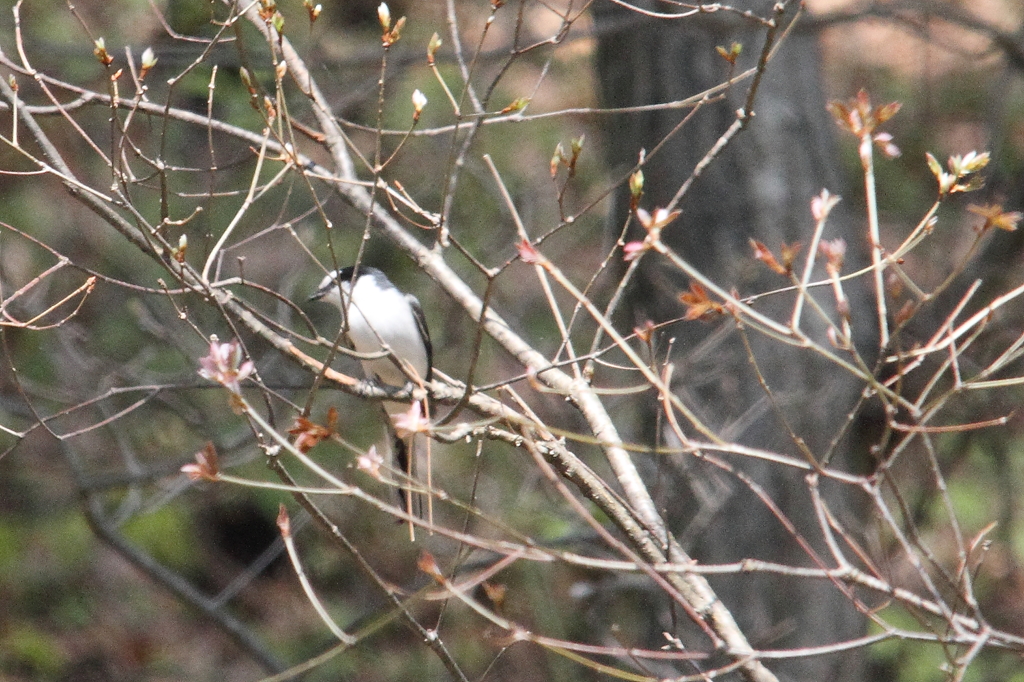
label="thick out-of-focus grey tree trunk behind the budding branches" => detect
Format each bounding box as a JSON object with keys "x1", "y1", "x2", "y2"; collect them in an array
[{"x1": 594, "y1": 1, "x2": 878, "y2": 681}]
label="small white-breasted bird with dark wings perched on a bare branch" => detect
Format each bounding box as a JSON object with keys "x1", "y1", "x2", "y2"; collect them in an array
[{"x1": 309, "y1": 265, "x2": 433, "y2": 520}]
